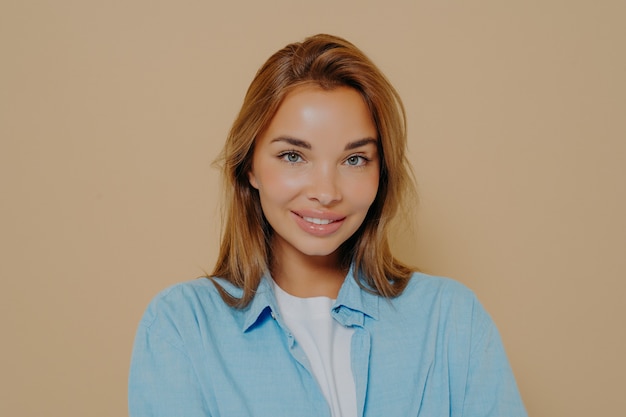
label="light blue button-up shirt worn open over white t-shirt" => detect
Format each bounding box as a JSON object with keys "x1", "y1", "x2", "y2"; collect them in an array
[{"x1": 129, "y1": 273, "x2": 526, "y2": 417}]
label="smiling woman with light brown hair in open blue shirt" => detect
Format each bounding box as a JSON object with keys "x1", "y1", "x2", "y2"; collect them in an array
[{"x1": 129, "y1": 35, "x2": 526, "y2": 417}]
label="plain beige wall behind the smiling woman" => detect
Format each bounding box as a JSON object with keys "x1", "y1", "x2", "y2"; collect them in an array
[{"x1": 0, "y1": 0, "x2": 626, "y2": 417}]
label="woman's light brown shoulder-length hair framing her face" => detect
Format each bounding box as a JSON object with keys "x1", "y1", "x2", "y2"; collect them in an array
[{"x1": 212, "y1": 34, "x2": 415, "y2": 308}]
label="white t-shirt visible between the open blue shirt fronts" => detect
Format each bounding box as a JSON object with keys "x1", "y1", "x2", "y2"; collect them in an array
[{"x1": 274, "y1": 283, "x2": 357, "y2": 417}]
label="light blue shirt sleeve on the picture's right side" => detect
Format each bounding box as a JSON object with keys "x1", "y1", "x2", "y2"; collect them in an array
[{"x1": 463, "y1": 300, "x2": 527, "y2": 417}]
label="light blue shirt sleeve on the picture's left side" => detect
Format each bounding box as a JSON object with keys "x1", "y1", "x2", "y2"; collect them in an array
[{"x1": 128, "y1": 302, "x2": 210, "y2": 417}]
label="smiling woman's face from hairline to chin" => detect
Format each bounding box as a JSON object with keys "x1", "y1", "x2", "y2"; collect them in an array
[{"x1": 249, "y1": 86, "x2": 380, "y2": 264}]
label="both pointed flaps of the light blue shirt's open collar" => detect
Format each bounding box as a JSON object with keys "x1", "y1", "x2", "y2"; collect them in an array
[{"x1": 242, "y1": 267, "x2": 380, "y2": 332}]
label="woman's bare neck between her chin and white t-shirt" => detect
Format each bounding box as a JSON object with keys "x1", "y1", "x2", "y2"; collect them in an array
[{"x1": 271, "y1": 239, "x2": 347, "y2": 299}]
